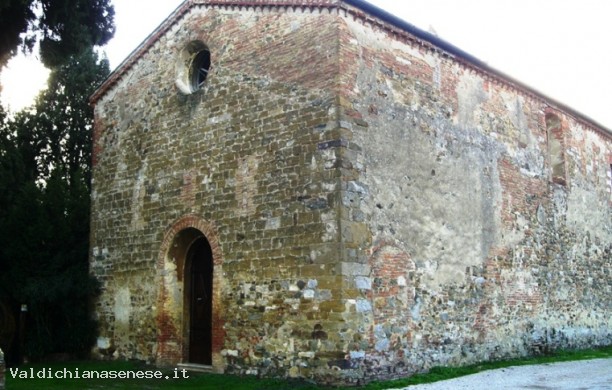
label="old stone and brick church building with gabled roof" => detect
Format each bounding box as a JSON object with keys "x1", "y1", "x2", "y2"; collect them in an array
[{"x1": 91, "y1": 0, "x2": 612, "y2": 384}]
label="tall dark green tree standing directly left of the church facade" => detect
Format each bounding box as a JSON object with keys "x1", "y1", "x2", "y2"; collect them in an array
[{"x1": 0, "y1": 50, "x2": 109, "y2": 357}]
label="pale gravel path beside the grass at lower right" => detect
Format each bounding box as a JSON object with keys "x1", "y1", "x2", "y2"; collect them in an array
[{"x1": 396, "y1": 359, "x2": 612, "y2": 390}]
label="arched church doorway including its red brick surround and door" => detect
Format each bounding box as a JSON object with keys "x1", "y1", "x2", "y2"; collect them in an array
[{"x1": 155, "y1": 214, "x2": 225, "y2": 371}]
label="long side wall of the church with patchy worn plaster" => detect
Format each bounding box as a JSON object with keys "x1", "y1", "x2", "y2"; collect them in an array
[{"x1": 339, "y1": 12, "x2": 612, "y2": 379}]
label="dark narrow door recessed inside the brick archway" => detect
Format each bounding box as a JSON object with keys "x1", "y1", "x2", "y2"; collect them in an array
[{"x1": 183, "y1": 236, "x2": 213, "y2": 365}]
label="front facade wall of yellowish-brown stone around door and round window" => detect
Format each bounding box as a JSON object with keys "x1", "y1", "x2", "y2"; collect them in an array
[{"x1": 91, "y1": 6, "x2": 354, "y2": 377}]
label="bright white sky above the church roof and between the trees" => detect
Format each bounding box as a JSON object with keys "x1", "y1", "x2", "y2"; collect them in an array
[{"x1": 2, "y1": 0, "x2": 612, "y2": 129}]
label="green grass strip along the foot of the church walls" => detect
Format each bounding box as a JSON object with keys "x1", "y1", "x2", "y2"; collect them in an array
[{"x1": 6, "y1": 346, "x2": 612, "y2": 390}]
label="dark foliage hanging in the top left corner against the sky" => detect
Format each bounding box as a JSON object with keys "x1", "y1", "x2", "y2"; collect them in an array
[{"x1": 0, "y1": 0, "x2": 115, "y2": 68}]
